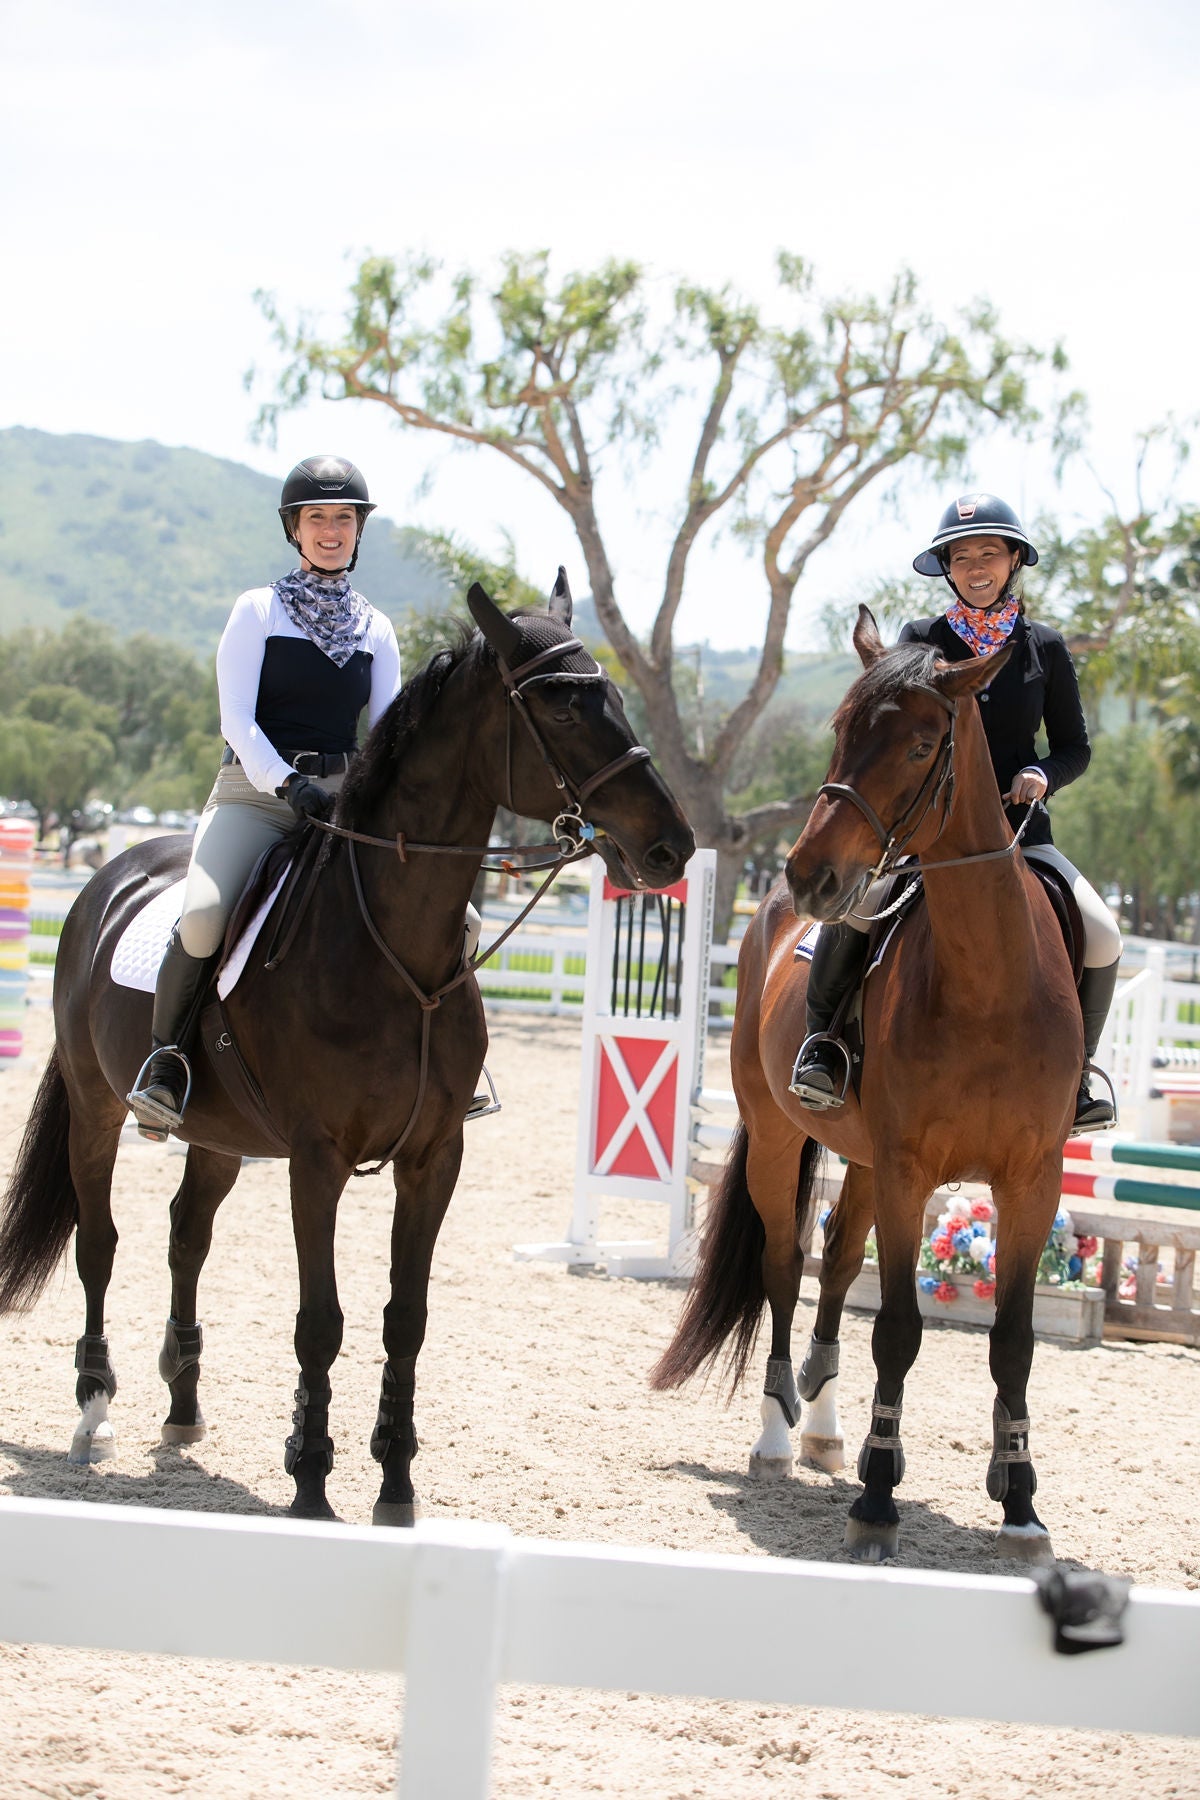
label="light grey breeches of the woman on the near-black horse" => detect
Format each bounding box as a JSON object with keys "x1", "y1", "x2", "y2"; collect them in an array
[{"x1": 180, "y1": 763, "x2": 345, "y2": 956}]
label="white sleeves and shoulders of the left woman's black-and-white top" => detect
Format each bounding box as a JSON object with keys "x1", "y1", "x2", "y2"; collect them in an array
[{"x1": 216, "y1": 587, "x2": 399, "y2": 794}]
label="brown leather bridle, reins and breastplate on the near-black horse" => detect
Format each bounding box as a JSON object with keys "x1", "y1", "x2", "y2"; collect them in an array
[{"x1": 264, "y1": 637, "x2": 649, "y2": 1175}]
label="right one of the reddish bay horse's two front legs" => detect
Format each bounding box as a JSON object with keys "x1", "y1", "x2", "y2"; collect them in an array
[{"x1": 988, "y1": 1156, "x2": 1061, "y2": 1562}]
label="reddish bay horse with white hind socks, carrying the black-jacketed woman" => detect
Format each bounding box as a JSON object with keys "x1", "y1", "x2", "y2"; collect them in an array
[{"x1": 651, "y1": 607, "x2": 1083, "y2": 1561}]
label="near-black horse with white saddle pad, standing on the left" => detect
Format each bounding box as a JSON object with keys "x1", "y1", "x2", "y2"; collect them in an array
[{"x1": 0, "y1": 578, "x2": 694, "y2": 1525}]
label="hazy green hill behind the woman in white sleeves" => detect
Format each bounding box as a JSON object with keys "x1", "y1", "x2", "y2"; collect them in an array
[{"x1": 0, "y1": 427, "x2": 450, "y2": 652}]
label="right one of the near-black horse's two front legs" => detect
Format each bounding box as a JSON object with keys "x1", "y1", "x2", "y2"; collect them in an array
[{"x1": 371, "y1": 1127, "x2": 462, "y2": 1525}]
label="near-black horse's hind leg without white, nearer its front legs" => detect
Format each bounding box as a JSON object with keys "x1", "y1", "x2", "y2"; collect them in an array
[{"x1": 158, "y1": 1145, "x2": 241, "y2": 1444}]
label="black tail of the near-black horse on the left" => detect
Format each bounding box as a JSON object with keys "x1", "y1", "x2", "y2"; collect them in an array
[{"x1": 0, "y1": 1049, "x2": 79, "y2": 1312}]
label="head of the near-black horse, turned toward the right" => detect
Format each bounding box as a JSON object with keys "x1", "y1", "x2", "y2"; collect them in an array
[{"x1": 468, "y1": 569, "x2": 696, "y2": 887}]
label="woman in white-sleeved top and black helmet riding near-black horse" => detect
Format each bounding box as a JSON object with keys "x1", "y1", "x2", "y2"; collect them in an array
[{"x1": 128, "y1": 457, "x2": 399, "y2": 1138}]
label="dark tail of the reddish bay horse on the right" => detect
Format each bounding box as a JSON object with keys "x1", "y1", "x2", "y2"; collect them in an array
[{"x1": 649, "y1": 1123, "x2": 820, "y2": 1391}]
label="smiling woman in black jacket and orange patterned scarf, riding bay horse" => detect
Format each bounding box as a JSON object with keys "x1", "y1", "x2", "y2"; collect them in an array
[{"x1": 792, "y1": 493, "x2": 1121, "y2": 1132}]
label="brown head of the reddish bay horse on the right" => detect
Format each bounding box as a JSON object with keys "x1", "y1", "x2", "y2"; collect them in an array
[{"x1": 786, "y1": 607, "x2": 1013, "y2": 918}]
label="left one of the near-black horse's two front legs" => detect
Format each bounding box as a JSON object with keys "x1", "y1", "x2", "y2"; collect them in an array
[{"x1": 284, "y1": 1139, "x2": 349, "y2": 1519}]
